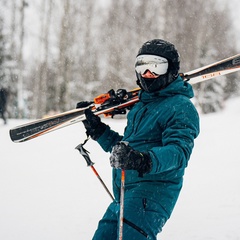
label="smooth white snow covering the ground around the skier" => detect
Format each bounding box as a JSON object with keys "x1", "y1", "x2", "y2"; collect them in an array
[{"x1": 0, "y1": 98, "x2": 240, "y2": 240}]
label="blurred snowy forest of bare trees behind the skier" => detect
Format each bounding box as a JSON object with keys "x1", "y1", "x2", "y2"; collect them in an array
[{"x1": 0, "y1": 0, "x2": 240, "y2": 118}]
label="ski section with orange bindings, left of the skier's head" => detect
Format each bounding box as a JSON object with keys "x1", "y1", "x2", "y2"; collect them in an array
[{"x1": 9, "y1": 88, "x2": 139, "y2": 143}]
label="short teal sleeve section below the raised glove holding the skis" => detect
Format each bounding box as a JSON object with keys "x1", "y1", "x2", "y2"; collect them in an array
[{"x1": 97, "y1": 126, "x2": 123, "y2": 152}]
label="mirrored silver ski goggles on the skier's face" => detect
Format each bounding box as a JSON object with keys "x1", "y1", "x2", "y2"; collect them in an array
[{"x1": 135, "y1": 55, "x2": 168, "y2": 75}]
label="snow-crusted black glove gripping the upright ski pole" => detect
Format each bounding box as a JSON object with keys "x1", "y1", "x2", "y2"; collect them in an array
[{"x1": 110, "y1": 142, "x2": 152, "y2": 177}]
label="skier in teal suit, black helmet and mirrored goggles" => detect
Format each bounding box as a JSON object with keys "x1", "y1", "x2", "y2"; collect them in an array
[{"x1": 77, "y1": 39, "x2": 199, "y2": 240}]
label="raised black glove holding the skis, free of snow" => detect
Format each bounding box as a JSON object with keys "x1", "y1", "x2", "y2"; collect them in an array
[{"x1": 77, "y1": 102, "x2": 107, "y2": 140}]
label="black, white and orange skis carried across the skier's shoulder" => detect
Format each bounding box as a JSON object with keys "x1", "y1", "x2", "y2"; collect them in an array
[{"x1": 10, "y1": 54, "x2": 240, "y2": 143}]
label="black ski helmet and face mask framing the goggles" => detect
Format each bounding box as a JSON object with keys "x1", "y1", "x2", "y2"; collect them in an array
[{"x1": 136, "y1": 39, "x2": 180, "y2": 92}]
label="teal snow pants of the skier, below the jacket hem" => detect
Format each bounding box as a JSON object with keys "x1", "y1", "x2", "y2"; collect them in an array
[{"x1": 92, "y1": 198, "x2": 168, "y2": 240}]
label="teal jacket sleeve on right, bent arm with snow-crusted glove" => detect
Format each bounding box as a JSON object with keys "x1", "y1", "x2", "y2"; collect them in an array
[{"x1": 149, "y1": 102, "x2": 199, "y2": 174}]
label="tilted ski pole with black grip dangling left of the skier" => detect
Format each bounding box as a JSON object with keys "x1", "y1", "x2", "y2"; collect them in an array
[{"x1": 75, "y1": 138, "x2": 114, "y2": 201}]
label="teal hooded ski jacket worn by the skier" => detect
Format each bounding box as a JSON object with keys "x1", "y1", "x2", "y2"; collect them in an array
[{"x1": 98, "y1": 76, "x2": 199, "y2": 218}]
